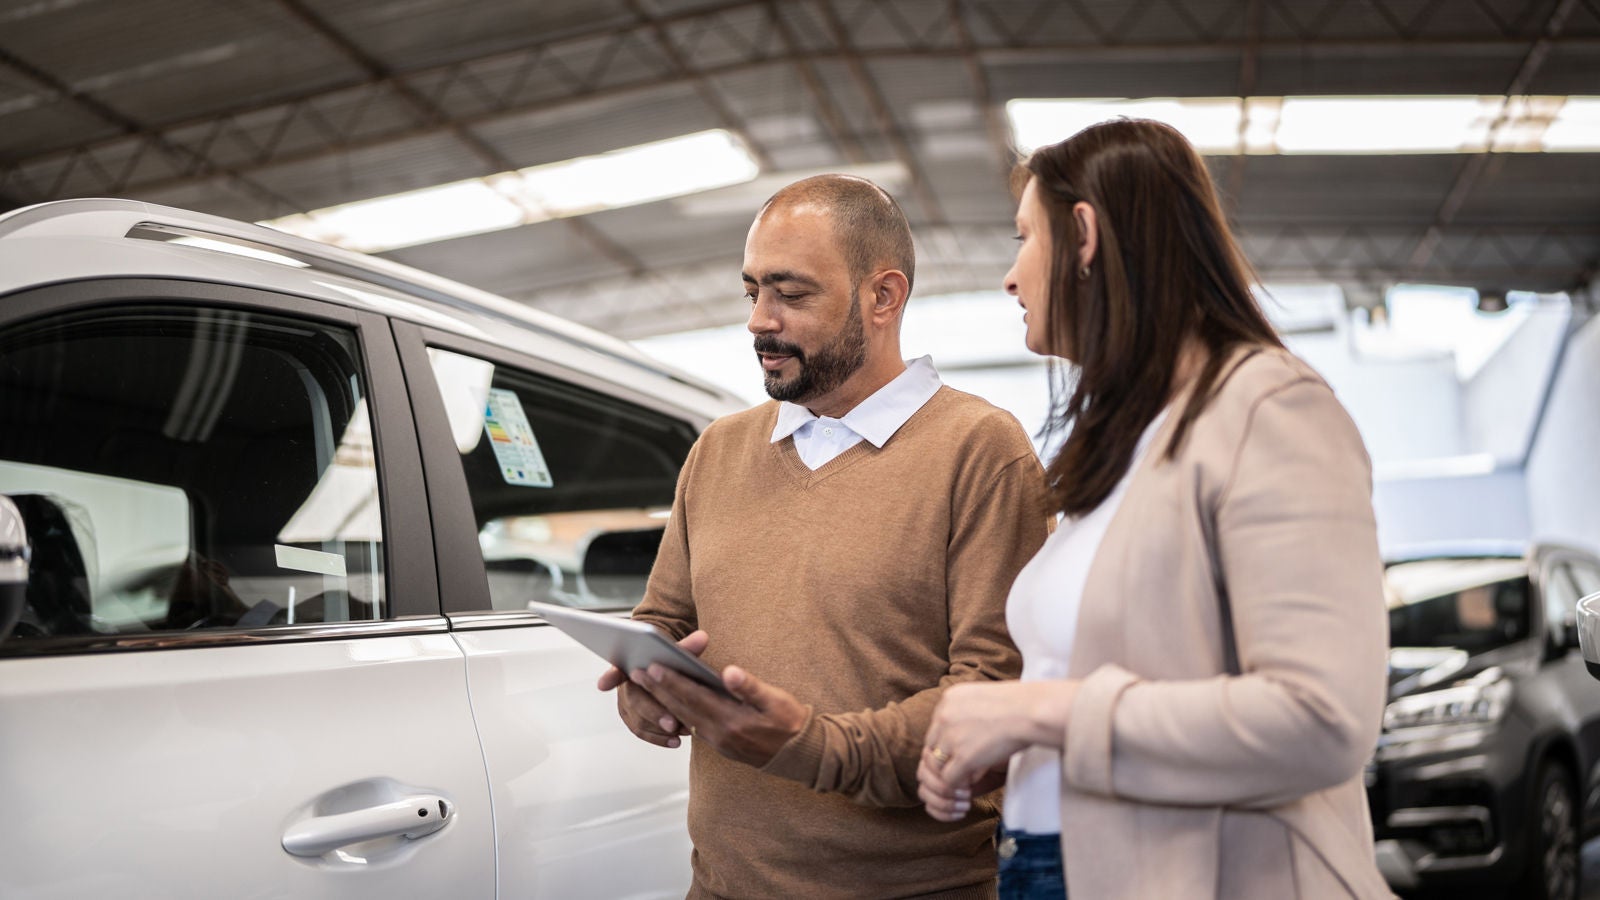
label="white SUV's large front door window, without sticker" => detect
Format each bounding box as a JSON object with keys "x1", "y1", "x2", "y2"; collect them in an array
[{"x1": 0, "y1": 307, "x2": 384, "y2": 641}]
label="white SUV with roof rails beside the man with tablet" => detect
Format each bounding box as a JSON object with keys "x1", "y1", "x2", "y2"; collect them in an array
[{"x1": 0, "y1": 200, "x2": 739, "y2": 900}]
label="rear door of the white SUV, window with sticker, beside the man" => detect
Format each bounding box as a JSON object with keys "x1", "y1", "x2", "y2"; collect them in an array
[{"x1": 395, "y1": 323, "x2": 704, "y2": 898}]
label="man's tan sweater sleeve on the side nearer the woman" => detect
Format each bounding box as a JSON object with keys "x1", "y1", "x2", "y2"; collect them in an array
[{"x1": 763, "y1": 436, "x2": 1050, "y2": 807}]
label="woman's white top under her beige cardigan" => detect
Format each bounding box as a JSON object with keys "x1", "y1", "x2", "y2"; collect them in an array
[{"x1": 1003, "y1": 410, "x2": 1166, "y2": 834}]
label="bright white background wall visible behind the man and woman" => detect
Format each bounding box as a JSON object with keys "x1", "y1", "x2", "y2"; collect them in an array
[{"x1": 638, "y1": 288, "x2": 1600, "y2": 549}]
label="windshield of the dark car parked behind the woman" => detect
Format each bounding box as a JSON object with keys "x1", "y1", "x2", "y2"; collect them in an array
[{"x1": 1384, "y1": 557, "x2": 1531, "y2": 653}]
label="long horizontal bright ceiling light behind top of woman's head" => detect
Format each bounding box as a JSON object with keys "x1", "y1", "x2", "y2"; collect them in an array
[{"x1": 1006, "y1": 94, "x2": 1600, "y2": 154}]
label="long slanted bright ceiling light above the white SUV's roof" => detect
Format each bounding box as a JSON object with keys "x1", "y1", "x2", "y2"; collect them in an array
[{"x1": 259, "y1": 130, "x2": 760, "y2": 253}]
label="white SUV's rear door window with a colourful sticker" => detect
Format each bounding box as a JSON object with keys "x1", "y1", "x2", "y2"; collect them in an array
[{"x1": 429, "y1": 348, "x2": 694, "y2": 610}]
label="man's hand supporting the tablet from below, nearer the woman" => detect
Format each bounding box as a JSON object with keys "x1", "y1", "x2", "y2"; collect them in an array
[{"x1": 632, "y1": 659, "x2": 811, "y2": 769}]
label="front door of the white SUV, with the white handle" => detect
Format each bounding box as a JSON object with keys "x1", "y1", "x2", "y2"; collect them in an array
[{"x1": 0, "y1": 279, "x2": 494, "y2": 900}]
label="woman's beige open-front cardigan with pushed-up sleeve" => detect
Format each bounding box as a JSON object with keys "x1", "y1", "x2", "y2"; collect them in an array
[{"x1": 1061, "y1": 349, "x2": 1390, "y2": 900}]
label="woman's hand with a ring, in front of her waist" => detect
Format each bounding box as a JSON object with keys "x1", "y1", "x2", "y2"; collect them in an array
[{"x1": 917, "y1": 681, "x2": 1078, "y2": 822}]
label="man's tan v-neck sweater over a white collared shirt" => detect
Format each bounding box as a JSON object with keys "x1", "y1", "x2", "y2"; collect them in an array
[{"x1": 635, "y1": 388, "x2": 1050, "y2": 898}]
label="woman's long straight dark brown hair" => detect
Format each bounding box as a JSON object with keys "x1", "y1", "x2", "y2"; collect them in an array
[{"x1": 1018, "y1": 119, "x2": 1283, "y2": 516}]
